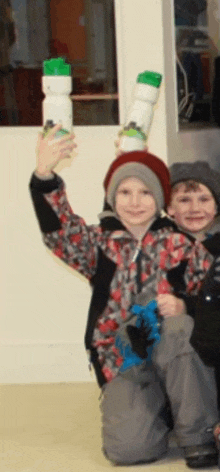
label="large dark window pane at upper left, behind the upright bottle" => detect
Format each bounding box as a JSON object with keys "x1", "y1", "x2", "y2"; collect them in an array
[{"x1": 0, "y1": 0, "x2": 119, "y2": 126}]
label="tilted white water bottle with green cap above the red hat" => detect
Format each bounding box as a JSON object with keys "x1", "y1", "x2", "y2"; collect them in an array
[{"x1": 119, "y1": 71, "x2": 162, "y2": 152}]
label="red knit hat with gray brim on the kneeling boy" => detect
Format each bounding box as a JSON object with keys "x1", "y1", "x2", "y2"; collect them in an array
[{"x1": 104, "y1": 151, "x2": 171, "y2": 210}]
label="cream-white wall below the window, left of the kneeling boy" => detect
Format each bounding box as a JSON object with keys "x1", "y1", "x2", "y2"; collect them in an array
[{"x1": 0, "y1": 127, "x2": 118, "y2": 383}]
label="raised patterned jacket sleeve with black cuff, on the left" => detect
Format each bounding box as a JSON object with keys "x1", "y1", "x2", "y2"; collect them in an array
[{"x1": 30, "y1": 174, "x2": 98, "y2": 279}]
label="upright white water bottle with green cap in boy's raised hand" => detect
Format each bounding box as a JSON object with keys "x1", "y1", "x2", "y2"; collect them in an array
[{"x1": 42, "y1": 57, "x2": 73, "y2": 132}]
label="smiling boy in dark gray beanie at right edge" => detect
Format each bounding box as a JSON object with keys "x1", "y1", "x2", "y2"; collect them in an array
[{"x1": 164, "y1": 161, "x2": 220, "y2": 365}]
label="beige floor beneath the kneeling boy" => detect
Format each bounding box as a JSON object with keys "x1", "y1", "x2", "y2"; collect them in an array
[{"x1": 0, "y1": 382, "x2": 219, "y2": 472}]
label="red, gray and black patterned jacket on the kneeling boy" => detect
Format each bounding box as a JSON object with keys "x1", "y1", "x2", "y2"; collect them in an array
[{"x1": 30, "y1": 174, "x2": 211, "y2": 386}]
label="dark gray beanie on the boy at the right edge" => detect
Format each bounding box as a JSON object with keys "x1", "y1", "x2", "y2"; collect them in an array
[{"x1": 169, "y1": 161, "x2": 220, "y2": 213}]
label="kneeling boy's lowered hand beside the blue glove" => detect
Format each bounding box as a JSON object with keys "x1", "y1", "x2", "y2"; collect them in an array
[{"x1": 157, "y1": 294, "x2": 186, "y2": 318}]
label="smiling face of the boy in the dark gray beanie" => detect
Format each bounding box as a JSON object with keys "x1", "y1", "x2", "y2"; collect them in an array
[{"x1": 167, "y1": 182, "x2": 217, "y2": 238}]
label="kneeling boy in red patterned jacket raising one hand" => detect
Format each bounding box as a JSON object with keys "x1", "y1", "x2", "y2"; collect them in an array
[{"x1": 30, "y1": 127, "x2": 217, "y2": 467}]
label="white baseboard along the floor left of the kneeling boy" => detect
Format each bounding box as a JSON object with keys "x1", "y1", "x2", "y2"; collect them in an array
[{"x1": 0, "y1": 341, "x2": 95, "y2": 384}]
